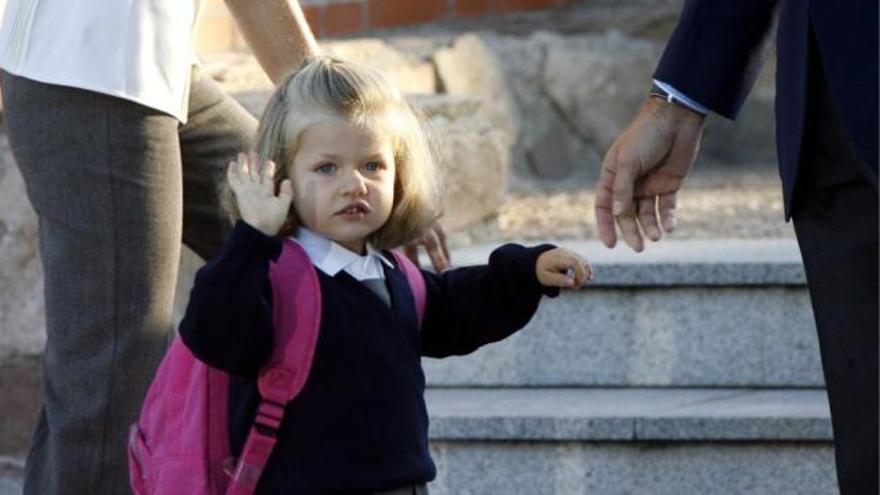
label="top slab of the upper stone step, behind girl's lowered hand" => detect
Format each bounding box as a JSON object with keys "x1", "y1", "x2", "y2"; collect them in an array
[{"x1": 444, "y1": 239, "x2": 806, "y2": 287}]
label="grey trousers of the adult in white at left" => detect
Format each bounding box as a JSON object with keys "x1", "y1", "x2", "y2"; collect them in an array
[{"x1": 2, "y1": 69, "x2": 256, "y2": 495}]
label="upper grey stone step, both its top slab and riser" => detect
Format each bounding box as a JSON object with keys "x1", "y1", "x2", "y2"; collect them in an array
[{"x1": 424, "y1": 240, "x2": 824, "y2": 387}]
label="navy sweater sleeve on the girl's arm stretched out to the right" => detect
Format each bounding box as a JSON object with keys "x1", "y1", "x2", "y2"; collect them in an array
[{"x1": 421, "y1": 244, "x2": 559, "y2": 357}]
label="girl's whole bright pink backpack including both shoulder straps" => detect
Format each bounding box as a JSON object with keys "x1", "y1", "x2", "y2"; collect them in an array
[{"x1": 128, "y1": 240, "x2": 425, "y2": 495}]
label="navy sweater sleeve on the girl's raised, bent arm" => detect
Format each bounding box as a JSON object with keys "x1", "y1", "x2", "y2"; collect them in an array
[{"x1": 180, "y1": 221, "x2": 282, "y2": 376}]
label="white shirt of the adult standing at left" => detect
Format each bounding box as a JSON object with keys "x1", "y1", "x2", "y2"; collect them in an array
[{"x1": 0, "y1": 0, "x2": 199, "y2": 122}]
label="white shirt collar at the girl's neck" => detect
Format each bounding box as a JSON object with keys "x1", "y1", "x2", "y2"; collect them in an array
[{"x1": 293, "y1": 227, "x2": 394, "y2": 281}]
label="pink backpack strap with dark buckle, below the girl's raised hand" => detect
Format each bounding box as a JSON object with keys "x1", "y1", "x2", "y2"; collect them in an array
[{"x1": 226, "y1": 239, "x2": 321, "y2": 495}]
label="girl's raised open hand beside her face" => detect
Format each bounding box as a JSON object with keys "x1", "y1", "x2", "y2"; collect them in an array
[{"x1": 226, "y1": 153, "x2": 293, "y2": 235}]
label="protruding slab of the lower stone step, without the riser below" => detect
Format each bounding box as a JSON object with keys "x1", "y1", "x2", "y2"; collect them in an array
[{"x1": 427, "y1": 389, "x2": 832, "y2": 443}]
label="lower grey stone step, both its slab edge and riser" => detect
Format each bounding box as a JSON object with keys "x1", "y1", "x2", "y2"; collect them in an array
[{"x1": 427, "y1": 388, "x2": 837, "y2": 495}]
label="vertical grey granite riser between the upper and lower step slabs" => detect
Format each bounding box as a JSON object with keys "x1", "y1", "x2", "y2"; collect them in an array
[{"x1": 423, "y1": 282, "x2": 824, "y2": 388}]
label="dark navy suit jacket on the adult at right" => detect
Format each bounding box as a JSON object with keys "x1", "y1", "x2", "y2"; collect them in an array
[{"x1": 654, "y1": 0, "x2": 878, "y2": 214}]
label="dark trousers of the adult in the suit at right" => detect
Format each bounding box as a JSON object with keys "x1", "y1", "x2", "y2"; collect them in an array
[{"x1": 792, "y1": 43, "x2": 880, "y2": 495}]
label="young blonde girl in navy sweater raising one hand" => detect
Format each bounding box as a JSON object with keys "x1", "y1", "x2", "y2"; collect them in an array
[{"x1": 180, "y1": 57, "x2": 590, "y2": 494}]
